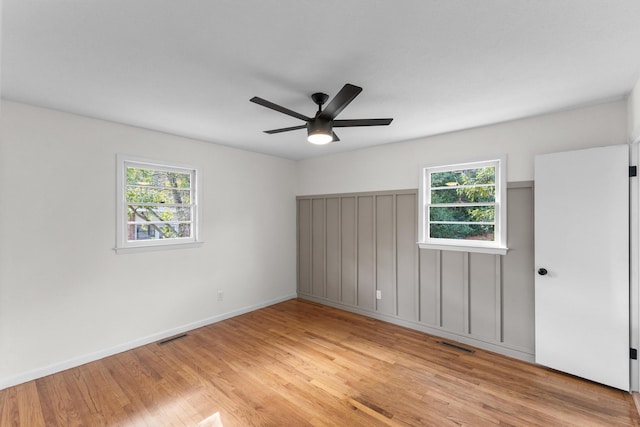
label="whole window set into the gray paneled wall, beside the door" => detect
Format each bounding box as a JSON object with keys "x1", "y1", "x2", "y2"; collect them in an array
[{"x1": 418, "y1": 158, "x2": 507, "y2": 254}]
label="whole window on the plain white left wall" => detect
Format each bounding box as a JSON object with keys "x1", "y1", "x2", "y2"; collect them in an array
[{"x1": 116, "y1": 156, "x2": 199, "y2": 252}]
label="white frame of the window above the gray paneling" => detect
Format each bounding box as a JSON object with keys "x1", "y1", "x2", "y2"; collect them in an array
[{"x1": 418, "y1": 156, "x2": 508, "y2": 255}]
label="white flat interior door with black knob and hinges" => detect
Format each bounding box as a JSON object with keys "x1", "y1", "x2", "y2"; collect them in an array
[{"x1": 535, "y1": 145, "x2": 629, "y2": 390}]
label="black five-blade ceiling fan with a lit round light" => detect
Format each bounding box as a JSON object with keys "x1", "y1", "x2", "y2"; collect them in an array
[{"x1": 250, "y1": 83, "x2": 393, "y2": 145}]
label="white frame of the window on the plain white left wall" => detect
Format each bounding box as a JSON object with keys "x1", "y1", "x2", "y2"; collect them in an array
[{"x1": 115, "y1": 154, "x2": 203, "y2": 254}]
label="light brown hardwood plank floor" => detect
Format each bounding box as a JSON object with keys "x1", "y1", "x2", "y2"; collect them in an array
[{"x1": 0, "y1": 300, "x2": 640, "y2": 427}]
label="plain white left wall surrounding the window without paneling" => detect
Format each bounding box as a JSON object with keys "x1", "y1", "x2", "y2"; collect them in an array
[{"x1": 0, "y1": 102, "x2": 296, "y2": 388}]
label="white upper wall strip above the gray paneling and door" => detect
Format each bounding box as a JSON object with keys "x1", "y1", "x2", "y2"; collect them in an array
[{"x1": 297, "y1": 100, "x2": 628, "y2": 195}]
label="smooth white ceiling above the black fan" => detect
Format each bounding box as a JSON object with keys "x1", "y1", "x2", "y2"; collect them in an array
[{"x1": 1, "y1": 0, "x2": 640, "y2": 159}]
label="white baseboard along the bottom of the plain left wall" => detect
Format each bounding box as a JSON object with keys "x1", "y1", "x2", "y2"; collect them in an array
[{"x1": 0, "y1": 294, "x2": 297, "y2": 390}]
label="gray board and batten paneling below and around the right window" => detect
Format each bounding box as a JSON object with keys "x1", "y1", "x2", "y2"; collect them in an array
[{"x1": 297, "y1": 181, "x2": 534, "y2": 361}]
